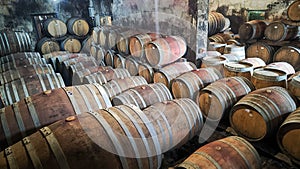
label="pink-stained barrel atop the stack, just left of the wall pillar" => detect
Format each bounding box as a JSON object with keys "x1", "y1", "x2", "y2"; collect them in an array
[{"x1": 145, "y1": 36, "x2": 187, "y2": 66}]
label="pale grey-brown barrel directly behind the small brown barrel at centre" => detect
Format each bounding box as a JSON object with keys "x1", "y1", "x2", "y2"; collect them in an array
[{"x1": 102, "y1": 76, "x2": 147, "y2": 99}]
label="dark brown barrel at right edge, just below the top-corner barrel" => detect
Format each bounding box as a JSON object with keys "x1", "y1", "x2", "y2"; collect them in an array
[{"x1": 265, "y1": 21, "x2": 298, "y2": 42}]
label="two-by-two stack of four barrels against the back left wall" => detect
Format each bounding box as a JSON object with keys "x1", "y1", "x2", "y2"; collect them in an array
[{"x1": 36, "y1": 17, "x2": 90, "y2": 54}]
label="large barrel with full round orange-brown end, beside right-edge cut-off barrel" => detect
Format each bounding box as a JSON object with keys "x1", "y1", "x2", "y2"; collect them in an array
[{"x1": 229, "y1": 86, "x2": 296, "y2": 141}]
